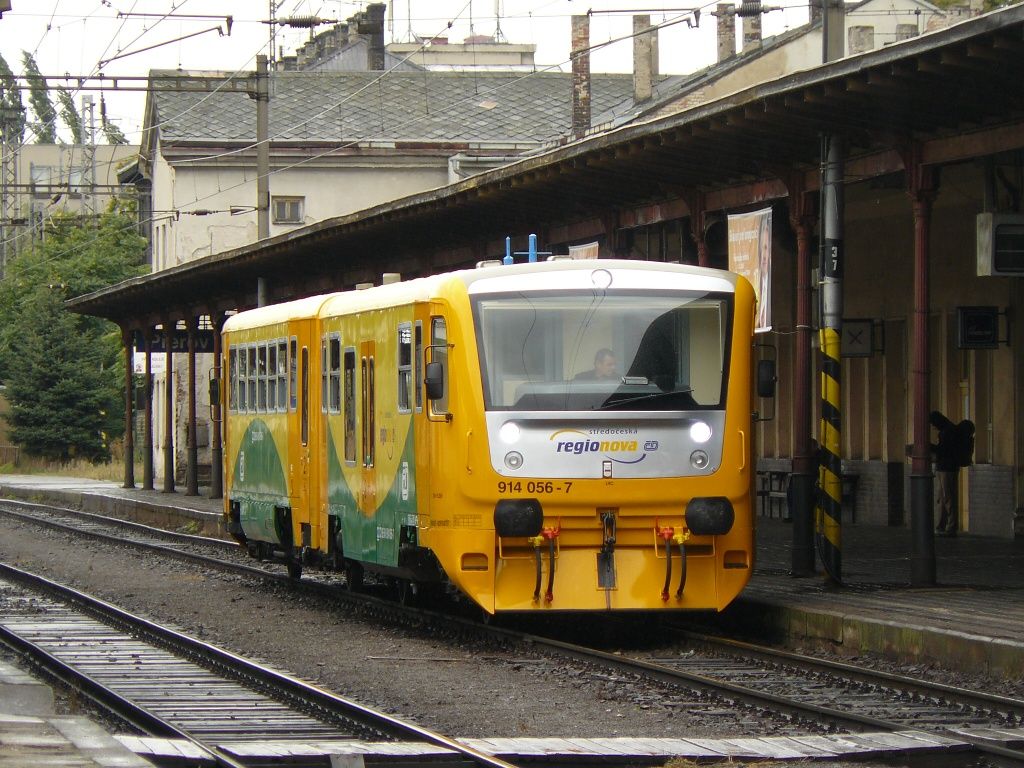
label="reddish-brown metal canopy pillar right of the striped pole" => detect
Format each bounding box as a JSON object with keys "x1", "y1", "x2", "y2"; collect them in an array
[{"x1": 903, "y1": 144, "x2": 936, "y2": 587}]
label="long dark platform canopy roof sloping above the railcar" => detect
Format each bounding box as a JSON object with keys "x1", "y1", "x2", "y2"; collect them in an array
[{"x1": 68, "y1": 5, "x2": 1024, "y2": 327}]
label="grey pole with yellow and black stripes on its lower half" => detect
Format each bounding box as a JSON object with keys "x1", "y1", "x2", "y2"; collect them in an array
[{"x1": 817, "y1": 135, "x2": 844, "y2": 583}]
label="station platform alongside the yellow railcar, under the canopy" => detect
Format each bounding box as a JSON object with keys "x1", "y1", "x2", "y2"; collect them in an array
[{"x1": 0, "y1": 475, "x2": 1024, "y2": 678}]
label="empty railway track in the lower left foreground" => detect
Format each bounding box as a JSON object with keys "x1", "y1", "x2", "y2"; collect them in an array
[{"x1": 0, "y1": 564, "x2": 510, "y2": 768}]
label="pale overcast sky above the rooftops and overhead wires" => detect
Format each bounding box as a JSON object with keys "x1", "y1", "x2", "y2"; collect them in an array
[{"x1": 0, "y1": 0, "x2": 808, "y2": 142}]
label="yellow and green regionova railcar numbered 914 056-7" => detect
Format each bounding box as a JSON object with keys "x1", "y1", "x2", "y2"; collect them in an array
[{"x1": 224, "y1": 260, "x2": 771, "y2": 613}]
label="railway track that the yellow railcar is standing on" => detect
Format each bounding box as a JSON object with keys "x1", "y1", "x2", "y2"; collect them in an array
[{"x1": 5, "y1": 503, "x2": 1024, "y2": 765}]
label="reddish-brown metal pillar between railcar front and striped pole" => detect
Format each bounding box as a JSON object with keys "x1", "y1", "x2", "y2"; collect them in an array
[{"x1": 790, "y1": 182, "x2": 818, "y2": 577}]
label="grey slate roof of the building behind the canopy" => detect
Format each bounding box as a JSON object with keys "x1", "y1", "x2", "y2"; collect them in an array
[{"x1": 146, "y1": 72, "x2": 633, "y2": 145}]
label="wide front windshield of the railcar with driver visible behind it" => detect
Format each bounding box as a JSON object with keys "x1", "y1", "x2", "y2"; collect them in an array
[{"x1": 474, "y1": 291, "x2": 732, "y2": 411}]
